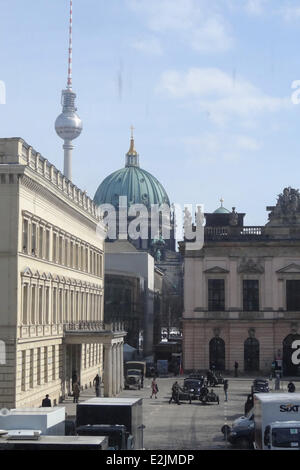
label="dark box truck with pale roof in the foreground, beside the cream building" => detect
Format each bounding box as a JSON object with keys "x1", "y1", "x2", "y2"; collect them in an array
[{"x1": 76, "y1": 398, "x2": 144, "y2": 450}]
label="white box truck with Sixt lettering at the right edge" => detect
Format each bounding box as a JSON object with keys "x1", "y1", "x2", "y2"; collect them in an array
[{"x1": 254, "y1": 393, "x2": 300, "y2": 450}]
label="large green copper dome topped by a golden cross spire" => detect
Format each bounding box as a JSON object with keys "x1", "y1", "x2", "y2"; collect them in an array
[{"x1": 94, "y1": 137, "x2": 170, "y2": 209}]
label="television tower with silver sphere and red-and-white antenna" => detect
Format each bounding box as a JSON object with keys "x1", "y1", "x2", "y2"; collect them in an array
[{"x1": 55, "y1": 0, "x2": 82, "y2": 180}]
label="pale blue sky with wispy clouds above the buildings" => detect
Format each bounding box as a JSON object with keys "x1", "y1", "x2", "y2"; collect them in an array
[{"x1": 0, "y1": 0, "x2": 300, "y2": 225}]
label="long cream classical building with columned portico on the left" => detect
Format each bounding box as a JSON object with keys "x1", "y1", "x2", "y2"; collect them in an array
[{"x1": 0, "y1": 138, "x2": 125, "y2": 407}]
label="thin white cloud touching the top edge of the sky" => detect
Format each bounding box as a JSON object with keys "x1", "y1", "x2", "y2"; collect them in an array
[{"x1": 128, "y1": 0, "x2": 233, "y2": 53}]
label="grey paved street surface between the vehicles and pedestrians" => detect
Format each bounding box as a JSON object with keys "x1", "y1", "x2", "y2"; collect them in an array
[{"x1": 61, "y1": 376, "x2": 298, "y2": 450}]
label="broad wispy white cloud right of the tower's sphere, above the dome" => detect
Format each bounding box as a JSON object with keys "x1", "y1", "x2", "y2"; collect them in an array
[{"x1": 158, "y1": 68, "x2": 291, "y2": 124}]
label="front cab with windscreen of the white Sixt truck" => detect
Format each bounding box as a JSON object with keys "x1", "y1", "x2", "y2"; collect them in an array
[{"x1": 264, "y1": 421, "x2": 300, "y2": 450}]
